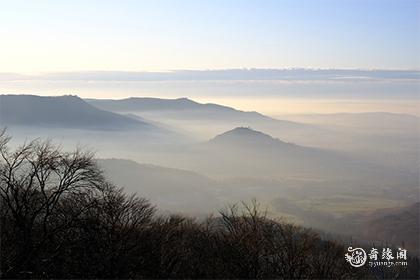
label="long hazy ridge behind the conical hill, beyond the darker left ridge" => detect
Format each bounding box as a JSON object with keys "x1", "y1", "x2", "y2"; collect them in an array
[{"x1": 86, "y1": 97, "x2": 328, "y2": 141}]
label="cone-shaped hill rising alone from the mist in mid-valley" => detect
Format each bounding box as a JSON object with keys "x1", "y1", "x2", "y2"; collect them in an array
[{"x1": 169, "y1": 127, "x2": 412, "y2": 183}]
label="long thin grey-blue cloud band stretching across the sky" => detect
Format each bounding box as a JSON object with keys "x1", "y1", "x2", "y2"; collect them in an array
[{"x1": 0, "y1": 68, "x2": 420, "y2": 82}]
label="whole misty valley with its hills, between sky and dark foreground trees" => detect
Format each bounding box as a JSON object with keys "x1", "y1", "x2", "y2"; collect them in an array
[{"x1": 0, "y1": 95, "x2": 419, "y2": 255}]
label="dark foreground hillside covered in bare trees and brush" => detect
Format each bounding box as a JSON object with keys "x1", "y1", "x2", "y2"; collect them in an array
[{"x1": 0, "y1": 130, "x2": 418, "y2": 279}]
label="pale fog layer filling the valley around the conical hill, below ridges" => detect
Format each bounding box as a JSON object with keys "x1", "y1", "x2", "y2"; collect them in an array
[{"x1": 2, "y1": 95, "x2": 419, "y2": 249}]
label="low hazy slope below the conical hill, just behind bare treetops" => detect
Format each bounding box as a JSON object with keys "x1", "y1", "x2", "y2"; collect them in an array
[{"x1": 98, "y1": 159, "x2": 219, "y2": 213}]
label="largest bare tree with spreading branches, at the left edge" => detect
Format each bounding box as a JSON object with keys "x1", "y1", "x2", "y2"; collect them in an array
[{"x1": 0, "y1": 131, "x2": 103, "y2": 277}]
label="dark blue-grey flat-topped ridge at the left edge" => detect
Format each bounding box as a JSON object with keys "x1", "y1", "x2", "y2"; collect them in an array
[{"x1": 0, "y1": 95, "x2": 153, "y2": 130}]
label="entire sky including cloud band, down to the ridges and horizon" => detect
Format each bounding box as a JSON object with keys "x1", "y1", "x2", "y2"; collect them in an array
[{"x1": 0, "y1": 0, "x2": 420, "y2": 115}]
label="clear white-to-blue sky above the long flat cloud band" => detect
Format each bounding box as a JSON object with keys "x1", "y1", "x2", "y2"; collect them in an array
[{"x1": 0, "y1": 0, "x2": 420, "y2": 73}]
